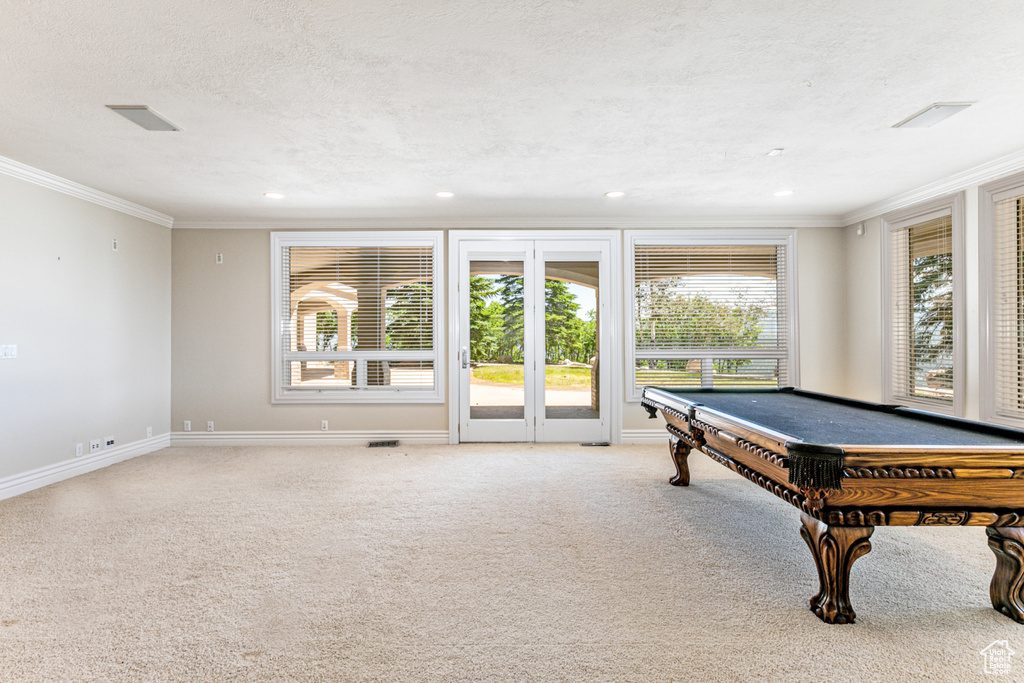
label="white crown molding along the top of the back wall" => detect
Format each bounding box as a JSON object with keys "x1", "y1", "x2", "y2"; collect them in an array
[{"x1": 174, "y1": 216, "x2": 846, "y2": 230}]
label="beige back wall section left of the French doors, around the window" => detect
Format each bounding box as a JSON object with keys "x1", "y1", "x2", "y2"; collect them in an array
[{"x1": 171, "y1": 229, "x2": 447, "y2": 432}]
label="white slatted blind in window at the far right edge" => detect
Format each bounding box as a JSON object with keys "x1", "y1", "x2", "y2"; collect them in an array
[{"x1": 989, "y1": 187, "x2": 1024, "y2": 419}]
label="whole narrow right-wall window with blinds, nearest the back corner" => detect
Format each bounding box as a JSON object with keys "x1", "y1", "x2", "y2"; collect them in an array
[{"x1": 883, "y1": 196, "x2": 964, "y2": 415}]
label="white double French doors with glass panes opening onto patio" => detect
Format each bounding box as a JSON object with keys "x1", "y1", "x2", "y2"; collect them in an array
[{"x1": 453, "y1": 239, "x2": 613, "y2": 442}]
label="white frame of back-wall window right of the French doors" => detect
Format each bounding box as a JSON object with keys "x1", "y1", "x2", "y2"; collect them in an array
[{"x1": 624, "y1": 228, "x2": 800, "y2": 403}]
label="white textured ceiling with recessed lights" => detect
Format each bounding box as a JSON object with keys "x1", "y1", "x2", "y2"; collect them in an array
[{"x1": 0, "y1": 0, "x2": 1024, "y2": 221}]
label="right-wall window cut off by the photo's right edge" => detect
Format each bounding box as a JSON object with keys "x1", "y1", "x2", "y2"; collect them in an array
[{"x1": 981, "y1": 175, "x2": 1024, "y2": 427}]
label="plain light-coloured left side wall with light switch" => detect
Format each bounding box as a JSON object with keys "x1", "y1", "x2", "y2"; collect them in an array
[{"x1": 0, "y1": 176, "x2": 171, "y2": 477}]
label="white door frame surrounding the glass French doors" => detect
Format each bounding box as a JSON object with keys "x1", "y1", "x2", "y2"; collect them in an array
[{"x1": 446, "y1": 229, "x2": 626, "y2": 443}]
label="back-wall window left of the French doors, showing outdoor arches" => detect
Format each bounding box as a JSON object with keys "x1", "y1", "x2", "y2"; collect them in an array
[{"x1": 271, "y1": 232, "x2": 442, "y2": 402}]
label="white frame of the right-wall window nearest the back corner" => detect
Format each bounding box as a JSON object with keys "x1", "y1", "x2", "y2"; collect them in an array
[{"x1": 881, "y1": 193, "x2": 967, "y2": 417}]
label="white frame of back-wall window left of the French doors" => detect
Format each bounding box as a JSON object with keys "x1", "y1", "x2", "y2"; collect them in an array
[{"x1": 270, "y1": 230, "x2": 446, "y2": 404}]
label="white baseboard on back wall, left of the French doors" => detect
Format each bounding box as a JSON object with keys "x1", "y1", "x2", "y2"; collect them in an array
[{"x1": 171, "y1": 429, "x2": 449, "y2": 446}]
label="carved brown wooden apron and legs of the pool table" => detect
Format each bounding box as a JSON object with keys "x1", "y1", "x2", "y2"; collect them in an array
[{"x1": 642, "y1": 389, "x2": 1024, "y2": 624}]
